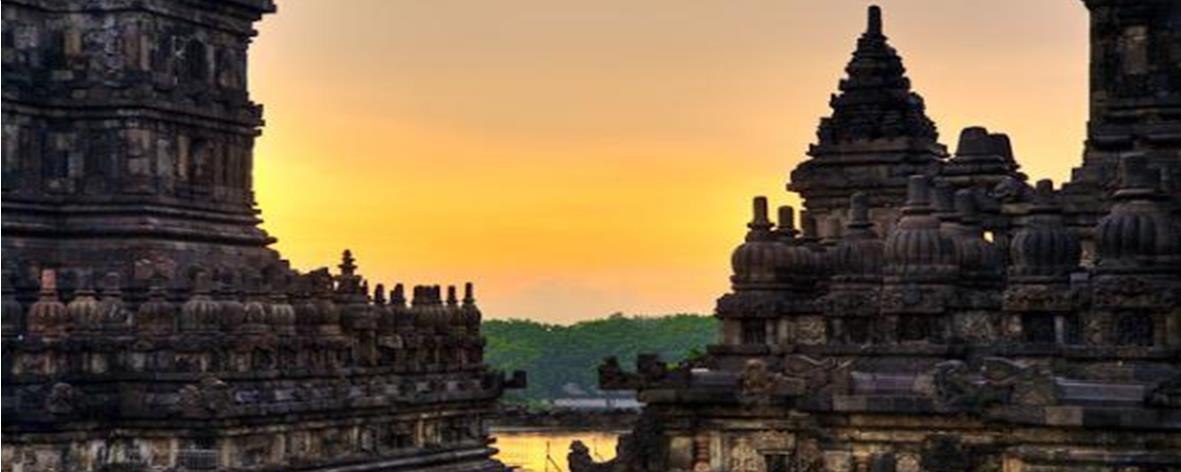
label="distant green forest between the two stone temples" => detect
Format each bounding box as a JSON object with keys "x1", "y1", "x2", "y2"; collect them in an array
[{"x1": 483, "y1": 313, "x2": 717, "y2": 401}]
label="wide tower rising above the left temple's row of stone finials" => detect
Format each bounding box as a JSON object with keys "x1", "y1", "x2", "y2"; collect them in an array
[{"x1": 2, "y1": 0, "x2": 278, "y2": 283}]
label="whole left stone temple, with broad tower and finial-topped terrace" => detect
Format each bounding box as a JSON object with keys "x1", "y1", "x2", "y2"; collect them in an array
[{"x1": 2, "y1": 0, "x2": 524, "y2": 472}]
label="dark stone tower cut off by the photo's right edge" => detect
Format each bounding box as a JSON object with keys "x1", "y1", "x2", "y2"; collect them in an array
[{"x1": 1064, "y1": 0, "x2": 1181, "y2": 227}]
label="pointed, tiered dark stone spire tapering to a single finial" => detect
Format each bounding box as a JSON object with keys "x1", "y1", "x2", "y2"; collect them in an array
[{"x1": 788, "y1": 6, "x2": 947, "y2": 238}]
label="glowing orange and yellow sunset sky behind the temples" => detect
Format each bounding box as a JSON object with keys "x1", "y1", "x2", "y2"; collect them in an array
[{"x1": 250, "y1": 0, "x2": 1088, "y2": 322}]
